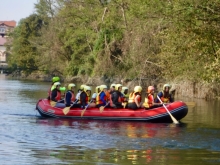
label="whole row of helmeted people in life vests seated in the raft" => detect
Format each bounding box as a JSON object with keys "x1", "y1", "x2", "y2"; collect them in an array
[{"x1": 48, "y1": 77, "x2": 174, "y2": 110}]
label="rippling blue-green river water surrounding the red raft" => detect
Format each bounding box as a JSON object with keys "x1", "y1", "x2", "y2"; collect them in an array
[{"x1": 0, "y1": 75, "x2": 220, "y2": 165}]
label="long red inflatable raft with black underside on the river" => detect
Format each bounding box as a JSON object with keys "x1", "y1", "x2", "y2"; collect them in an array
[{"x1": 36, "y1": 99, "x2": 188, "y2": 123}]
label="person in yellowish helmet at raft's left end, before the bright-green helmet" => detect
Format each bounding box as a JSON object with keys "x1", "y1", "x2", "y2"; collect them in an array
[{"x1": 50, "y1": 82, "x2": 66, "y2": 108}]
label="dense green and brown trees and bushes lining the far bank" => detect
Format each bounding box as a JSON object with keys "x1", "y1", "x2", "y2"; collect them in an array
[{"x1": 4, "y1": 0, "x2": 220, "y2": 99}]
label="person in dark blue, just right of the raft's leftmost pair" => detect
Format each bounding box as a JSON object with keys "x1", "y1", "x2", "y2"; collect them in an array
[{"x1": 65, "y1": 83, "x2": 80, "y2": 108}]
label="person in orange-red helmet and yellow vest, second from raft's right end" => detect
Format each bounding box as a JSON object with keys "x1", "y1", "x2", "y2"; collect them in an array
[{"x1": 143, "y1": 86, "x2": 163, "y2": 109}]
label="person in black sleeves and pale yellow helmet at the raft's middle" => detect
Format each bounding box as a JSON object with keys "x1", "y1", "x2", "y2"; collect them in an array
[{"x1": 110, "y1": 84, "x2": 123, "y2": 108}]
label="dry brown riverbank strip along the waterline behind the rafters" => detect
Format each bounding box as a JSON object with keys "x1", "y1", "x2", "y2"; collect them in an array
[{"x1": 8, "y1": 72, "x2": 220, "y2": 100}]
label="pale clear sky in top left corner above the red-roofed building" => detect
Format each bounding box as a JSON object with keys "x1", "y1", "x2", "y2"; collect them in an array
[{"x1": 0, "y1": 0, "x2": 38, "y2": 24}]
